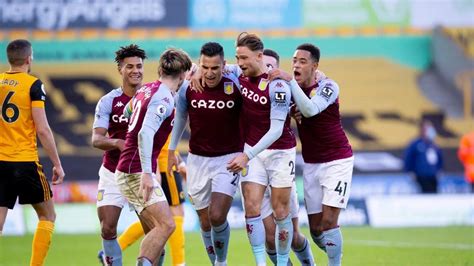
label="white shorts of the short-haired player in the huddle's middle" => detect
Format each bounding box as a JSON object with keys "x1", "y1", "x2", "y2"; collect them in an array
[{"x1": 186, "y1": 153, "x2": 240, "y2": 210}]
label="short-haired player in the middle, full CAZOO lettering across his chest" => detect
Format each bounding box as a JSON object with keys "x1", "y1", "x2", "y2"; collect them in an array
[{"x1": 169, "y1": 42, "x2": 243, "y2": 265}]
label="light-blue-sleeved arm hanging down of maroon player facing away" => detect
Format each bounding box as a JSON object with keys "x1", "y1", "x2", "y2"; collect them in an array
[{"x1": 138, "y1": 92, "x2": 174, "y2": 201}]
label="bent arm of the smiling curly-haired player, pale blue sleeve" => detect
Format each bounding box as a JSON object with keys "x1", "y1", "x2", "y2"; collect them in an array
[{"x1": 92, "y1": 96, "x2": 124, "y2": 151}]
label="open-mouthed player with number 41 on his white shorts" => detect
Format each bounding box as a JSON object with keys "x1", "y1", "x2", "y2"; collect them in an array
[{"x1": 272, "y1": 43, "x2": 354, "y2": 266}]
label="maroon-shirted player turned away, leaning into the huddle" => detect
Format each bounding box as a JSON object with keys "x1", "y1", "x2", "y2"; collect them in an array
[{"x1": 115, "y1": 49, "x2": 191, "y2": 265}]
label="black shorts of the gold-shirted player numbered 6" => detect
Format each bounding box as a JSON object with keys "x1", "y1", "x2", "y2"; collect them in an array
[{"x1": 0, "y1": 161, "x2": 53, "y2": 209}]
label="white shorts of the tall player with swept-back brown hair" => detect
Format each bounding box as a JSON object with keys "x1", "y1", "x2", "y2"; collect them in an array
[{"x1": 240, "y1": 147, "x2": 296, "y2": 188}]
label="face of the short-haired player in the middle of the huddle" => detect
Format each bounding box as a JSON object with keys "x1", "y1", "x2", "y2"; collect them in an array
[{"x1": 199, "y1": 55, "x2": 225, "y2": 88}]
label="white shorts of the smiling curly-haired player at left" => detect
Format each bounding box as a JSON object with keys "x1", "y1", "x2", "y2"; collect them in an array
[{"x1": 97, "y1": 165, "x2": 128, "y2": 208}]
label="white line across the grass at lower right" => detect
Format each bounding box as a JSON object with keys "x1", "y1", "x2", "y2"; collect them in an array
[{"x1": 344, "y1": 240, "x2": 474, "y2": 250}]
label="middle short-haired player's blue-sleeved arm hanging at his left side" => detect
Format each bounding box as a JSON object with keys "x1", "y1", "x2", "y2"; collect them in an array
[{"x1": 167, "y1": 84, "x2": 190, "y2": 174}]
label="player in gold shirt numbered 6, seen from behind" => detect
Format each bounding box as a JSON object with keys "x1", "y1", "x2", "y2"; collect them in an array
[{"x1": 0, "y1": 40, "x2": 64, "y2": 265}]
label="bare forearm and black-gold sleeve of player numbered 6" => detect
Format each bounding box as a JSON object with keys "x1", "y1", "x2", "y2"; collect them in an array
[{"x1": 30, "y1": 79, "x2": 64, "y2": 185}]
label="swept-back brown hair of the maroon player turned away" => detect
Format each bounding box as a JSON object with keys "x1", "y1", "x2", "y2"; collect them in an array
[{"x1": 158, "y1": 48, "x2": 192, "y2": 77}]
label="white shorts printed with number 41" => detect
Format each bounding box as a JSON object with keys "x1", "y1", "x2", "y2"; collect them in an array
[{"x1": 303, "y1": 156, "x2": 354, "y2": 214}]
